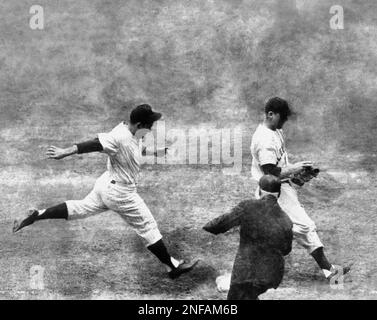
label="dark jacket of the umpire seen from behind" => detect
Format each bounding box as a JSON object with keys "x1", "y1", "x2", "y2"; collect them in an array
[{"x1": 203, "y1": 195, "x2": 293, "y2": 289}]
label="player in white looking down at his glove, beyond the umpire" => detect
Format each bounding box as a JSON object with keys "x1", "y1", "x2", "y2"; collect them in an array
[{"x1": 251, "y1": 97, "x2": 350, "y2": 283}]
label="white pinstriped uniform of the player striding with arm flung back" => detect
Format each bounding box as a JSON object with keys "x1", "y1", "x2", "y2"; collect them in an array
[{"x1": 66, "y1": 122, "x2": 162, "y2": 246}]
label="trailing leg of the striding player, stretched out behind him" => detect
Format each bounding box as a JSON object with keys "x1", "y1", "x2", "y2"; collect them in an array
[{"x1": 13, "y1": 179, "x2": 107, "y2": 232}]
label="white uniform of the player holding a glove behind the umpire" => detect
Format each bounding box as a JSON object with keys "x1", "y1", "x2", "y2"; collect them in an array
[{"x1": 250, "y1": 124, "x2": 323, "y2": 253}]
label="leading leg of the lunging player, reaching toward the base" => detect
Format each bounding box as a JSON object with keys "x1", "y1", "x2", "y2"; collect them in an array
[{"x1": 103, "y1": 187, "x2": 197, "y2": 278}]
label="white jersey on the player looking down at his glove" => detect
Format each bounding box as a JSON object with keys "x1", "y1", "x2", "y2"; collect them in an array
[{"x1": 250, "y1": 124, "x2": 288, "y2": 181}]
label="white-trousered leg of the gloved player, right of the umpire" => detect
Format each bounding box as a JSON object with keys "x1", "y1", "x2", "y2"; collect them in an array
[{"x1": 278, "y1": 183, "x2": 349, "y2": 278}]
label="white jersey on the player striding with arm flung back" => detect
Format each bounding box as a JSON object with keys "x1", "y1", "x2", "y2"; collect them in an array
[{"x1": 98, "y1": 122, "x2": 141, "y2": 184}]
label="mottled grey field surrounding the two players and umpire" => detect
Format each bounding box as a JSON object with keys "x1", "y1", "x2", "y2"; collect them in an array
[{"x1": 0, "y1": 0, "x2": 377, "y2": 299}]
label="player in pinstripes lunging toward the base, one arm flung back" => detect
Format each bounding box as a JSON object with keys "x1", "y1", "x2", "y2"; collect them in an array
[{"x1": 13, "y1": 104, "x2": 198, "y2": 279}]
